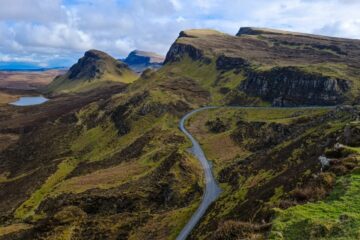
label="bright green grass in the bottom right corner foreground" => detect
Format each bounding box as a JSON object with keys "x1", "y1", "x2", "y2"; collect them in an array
[{"x1": 269, "y1": 169, "x2": 360, "y2": 240}]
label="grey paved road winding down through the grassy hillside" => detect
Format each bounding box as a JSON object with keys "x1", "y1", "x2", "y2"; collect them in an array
[{"x1": 176, "y1": 107, "x2": 221, "y2": 240}]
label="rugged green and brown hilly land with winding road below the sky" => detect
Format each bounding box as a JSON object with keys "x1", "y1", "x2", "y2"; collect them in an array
[{"x1": 0, "y1": 28, "x2": 360, "y2": 240}]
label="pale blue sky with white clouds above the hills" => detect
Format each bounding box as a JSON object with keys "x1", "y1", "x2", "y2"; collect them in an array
[{"x1": 0, "y1": 0, "x2": 360, "y2": 67}]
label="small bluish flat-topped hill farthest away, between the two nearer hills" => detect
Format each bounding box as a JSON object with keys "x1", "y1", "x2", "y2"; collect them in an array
[{"x1": 124, "y1": 50, "x2": 165, "y2": 73}]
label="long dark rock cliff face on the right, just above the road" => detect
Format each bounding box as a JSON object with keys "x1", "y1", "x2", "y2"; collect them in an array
[{"x1": 240, "y1": 67, "x2": 350, "y2": 106}]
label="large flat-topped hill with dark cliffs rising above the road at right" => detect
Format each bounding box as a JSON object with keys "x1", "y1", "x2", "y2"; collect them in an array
[{"x1": 165, "y1": 28, "x2": 360, "y2": 106}]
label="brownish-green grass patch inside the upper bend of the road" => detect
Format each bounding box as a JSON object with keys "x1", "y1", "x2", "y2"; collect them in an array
[{"x1": 186, "y1": 108, "x2": 329, "y2": 172}]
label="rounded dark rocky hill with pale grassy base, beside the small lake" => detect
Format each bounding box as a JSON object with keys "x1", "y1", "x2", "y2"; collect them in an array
[{"x1": 47, "y1": 50, "x2": 137, "y2": 93}]
